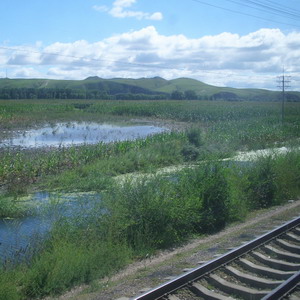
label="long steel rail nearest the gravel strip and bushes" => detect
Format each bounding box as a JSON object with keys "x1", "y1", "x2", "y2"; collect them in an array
[{"x1": 131, "y1": 217, "x2": 300, "y2": 300}]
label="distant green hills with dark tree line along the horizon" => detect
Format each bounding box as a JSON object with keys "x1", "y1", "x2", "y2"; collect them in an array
[{"x1": 0, "y1": 76, "x2": 300, "y2": 101}]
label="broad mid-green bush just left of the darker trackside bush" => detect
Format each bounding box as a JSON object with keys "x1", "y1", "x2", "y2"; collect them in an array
[{"x1": 104, "y1": 178, "x2": 176, "y2": 255}]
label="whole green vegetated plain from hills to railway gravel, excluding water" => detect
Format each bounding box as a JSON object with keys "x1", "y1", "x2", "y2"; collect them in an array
[{"x1": 0, "y1": 100, "x2": 300, "y2": 300}]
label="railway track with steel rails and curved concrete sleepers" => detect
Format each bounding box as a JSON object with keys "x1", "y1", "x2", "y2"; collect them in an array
[{"x1": 132, "y1": 217, "x2": 300, "y2": 300}]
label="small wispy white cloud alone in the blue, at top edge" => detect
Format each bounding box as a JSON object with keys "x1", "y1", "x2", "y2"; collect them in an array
[{"x1": 93, "y1": 0, "x2": 163, "y2": 21}]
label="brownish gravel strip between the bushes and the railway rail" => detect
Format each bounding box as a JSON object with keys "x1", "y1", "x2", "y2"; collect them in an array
[{"x1": 48, "y1": 200, "x2": 300, "y2": 300}]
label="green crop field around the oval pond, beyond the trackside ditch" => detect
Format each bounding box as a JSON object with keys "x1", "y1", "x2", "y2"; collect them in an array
[{"x1": 0, "y1": 100, "x2": 300, "y2": 196}]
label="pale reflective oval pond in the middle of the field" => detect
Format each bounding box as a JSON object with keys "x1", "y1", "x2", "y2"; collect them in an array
[{"x1": 0, "y1": 122, "x2": 167, "y2": 149}]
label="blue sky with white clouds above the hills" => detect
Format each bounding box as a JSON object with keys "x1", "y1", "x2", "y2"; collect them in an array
[{"x1": 0, "y1": 0, "x2": 300, "y2": 90}]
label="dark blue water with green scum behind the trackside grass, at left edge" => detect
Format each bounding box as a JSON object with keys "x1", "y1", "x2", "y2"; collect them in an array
[{"x1": 0, "y1": 192, "x2": 101, "y2": 262}]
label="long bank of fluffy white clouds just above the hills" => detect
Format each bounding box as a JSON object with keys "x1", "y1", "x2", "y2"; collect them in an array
[{"x1": 0, "y1": 27, "x2": 300, "y2": 89}]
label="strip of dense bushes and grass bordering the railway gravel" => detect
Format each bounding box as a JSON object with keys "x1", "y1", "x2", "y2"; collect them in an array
[{"x1": 0, "y1": 152, "x2": 300, "y2": 299}]
